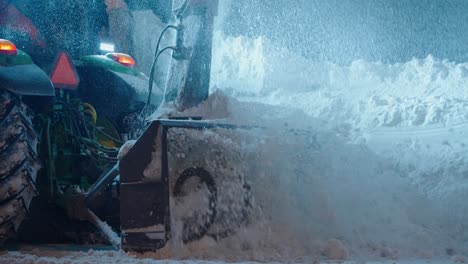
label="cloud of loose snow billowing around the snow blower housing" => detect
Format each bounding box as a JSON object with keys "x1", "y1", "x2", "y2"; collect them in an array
[{"x1": 151, "y1": 91, "x2": 454, "y2": 261}]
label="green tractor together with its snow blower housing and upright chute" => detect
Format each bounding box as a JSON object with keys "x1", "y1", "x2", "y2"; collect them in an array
[{"x1": 0, "y1": 0, "x2": 252, "y2": 251}]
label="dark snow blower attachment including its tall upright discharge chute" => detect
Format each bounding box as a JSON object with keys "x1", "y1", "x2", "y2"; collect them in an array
[{"x1": 115, "y1": 1, "x2": 233, "y2": 250}]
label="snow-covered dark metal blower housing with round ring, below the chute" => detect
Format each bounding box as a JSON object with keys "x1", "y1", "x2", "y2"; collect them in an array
[{"x1": 120, "y1": 120, "x2": 252, "y2": 250}]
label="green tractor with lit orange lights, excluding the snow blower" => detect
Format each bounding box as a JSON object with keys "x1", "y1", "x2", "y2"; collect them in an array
[{"x1": 0, "y1": 0, "x2": 200, "y2": 250}]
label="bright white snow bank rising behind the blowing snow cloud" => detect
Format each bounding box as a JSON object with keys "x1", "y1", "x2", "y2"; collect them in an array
[{"x1": 212, "y1": 32, "x2": 468, "y2": 237}]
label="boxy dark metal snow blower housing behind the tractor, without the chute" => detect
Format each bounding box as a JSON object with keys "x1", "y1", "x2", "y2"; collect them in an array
[{"x1": 120, "y1": 120, "x2": 251, "y2": 250}]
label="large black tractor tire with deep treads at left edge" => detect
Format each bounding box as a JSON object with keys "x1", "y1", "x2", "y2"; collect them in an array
[{"x1": 0, "y1": 89, "x2": 41, "y2": 247}]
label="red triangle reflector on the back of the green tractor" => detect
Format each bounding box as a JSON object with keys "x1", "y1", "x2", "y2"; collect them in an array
[{"x1": 49, "y1": 52, "x2": 80, "y2": 89}]
